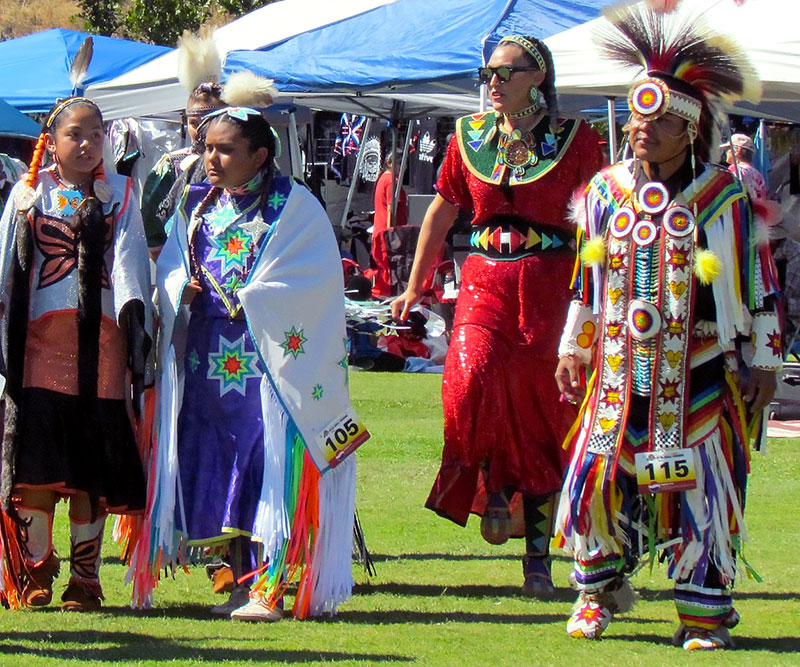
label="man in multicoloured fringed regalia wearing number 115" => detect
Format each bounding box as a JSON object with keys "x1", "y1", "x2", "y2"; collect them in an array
[{"x1": 556, "y1": 6, "x2": 782, "y2": 650}]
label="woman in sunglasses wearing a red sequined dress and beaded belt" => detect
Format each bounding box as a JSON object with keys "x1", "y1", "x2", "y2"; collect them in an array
[{"x1": 393, "y1": 36, "x2": 601, "y2": 596}]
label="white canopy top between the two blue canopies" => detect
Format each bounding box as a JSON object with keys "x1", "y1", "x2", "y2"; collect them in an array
[{"x1": 86, "y1": 0, "x2": 396, "y2": 120}]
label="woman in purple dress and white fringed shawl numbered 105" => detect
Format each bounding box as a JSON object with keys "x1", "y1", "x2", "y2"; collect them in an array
[{"x1": 140, "y1": 107, "x2": 368, "y2": 621}]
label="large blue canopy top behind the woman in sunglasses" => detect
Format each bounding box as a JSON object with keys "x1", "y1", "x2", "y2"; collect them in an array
[{"x1": 225, "y1": 0, "x2": 609, "y2": 109}]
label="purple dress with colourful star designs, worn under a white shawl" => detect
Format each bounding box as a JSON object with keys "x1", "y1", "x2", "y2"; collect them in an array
[{"x1": 176, "y1": 178, "x2": 291, "y2": 543}]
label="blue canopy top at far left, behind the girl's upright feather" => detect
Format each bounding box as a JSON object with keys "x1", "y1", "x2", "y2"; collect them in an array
[{"x1": 0, "y1": 28, "x2": 170, "y2": 113}]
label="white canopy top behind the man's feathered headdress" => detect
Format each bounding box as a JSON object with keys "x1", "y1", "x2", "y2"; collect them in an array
[{"x1": 545, "y1": 0, "x2": 800, "y2": 122}]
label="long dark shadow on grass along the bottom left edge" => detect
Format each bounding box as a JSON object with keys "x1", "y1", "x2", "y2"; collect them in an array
[{"x1": 0, "y1": 632, "x2": 413, "y2": 664}]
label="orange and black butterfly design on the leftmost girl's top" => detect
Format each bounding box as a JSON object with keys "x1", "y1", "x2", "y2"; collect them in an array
[{"x1": 33, "y1": 213, "x2": 114, "y2": 289}]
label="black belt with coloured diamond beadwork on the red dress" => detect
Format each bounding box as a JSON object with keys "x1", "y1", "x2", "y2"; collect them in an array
[{"x1": 469, "y1": 223, "x2": 574, "y2": 259}]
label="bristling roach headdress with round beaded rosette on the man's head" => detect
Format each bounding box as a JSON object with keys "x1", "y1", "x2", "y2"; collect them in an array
[{"x1": 595, "y1": 3, "x2": 761, "y2": 160}]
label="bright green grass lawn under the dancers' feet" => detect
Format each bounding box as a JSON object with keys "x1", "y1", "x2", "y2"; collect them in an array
[{"x1": 0, "y1": 374, "x2": 800, "y2": 665}]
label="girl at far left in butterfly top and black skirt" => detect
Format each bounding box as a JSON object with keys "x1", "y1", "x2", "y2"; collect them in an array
[{"x1": 0, "y1": 97, "x2": 151, "y2": 611}]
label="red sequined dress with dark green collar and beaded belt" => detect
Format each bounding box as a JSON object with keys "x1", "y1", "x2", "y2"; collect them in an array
[{"x1": 426, "y1": 112, "x2": 602, "y2": 525}]
